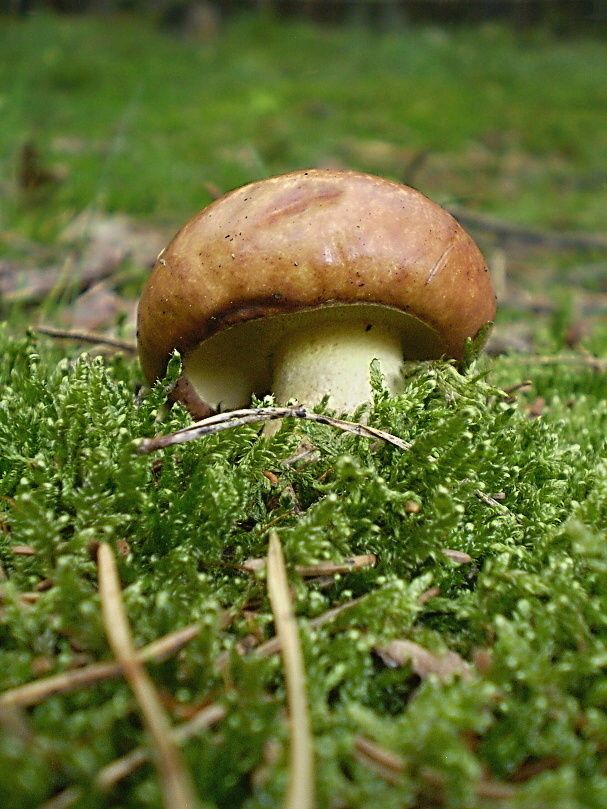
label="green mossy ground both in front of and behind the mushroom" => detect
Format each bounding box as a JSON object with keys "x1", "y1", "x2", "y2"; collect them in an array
[{"x1": 0, "y1": 7, "x2": 607, "y2": 809}]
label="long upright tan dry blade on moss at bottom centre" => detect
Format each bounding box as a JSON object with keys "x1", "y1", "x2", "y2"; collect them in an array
[{"x1": 268, "y1": 533, "x2": 314, "y2": 809}]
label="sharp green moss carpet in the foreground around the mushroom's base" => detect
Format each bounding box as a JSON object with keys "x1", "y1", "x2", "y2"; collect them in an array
[{"x1": 0, "y1": 330, "x2": 607, "y2": 809}]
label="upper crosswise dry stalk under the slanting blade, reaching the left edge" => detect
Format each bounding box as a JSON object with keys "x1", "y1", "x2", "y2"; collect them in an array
[{"x1": 0, "y1": 624, "x2": 200, "y2": 707}]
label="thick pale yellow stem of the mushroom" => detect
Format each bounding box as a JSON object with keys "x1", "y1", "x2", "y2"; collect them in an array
[{"x1": 272, "y1": 319, "x2": 403, "y2": 413}]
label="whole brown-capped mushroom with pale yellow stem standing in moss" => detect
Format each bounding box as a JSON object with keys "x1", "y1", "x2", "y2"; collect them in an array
[{"x1": 138, "y1": 170, "x2": 495, "y2": 418}]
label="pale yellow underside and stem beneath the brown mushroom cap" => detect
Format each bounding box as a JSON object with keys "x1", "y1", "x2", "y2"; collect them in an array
[{"x1": 184, "y1": 304, "x2": 445, "y2": 413}]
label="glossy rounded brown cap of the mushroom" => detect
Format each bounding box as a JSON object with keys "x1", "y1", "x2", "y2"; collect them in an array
[{"x1": 138, "y1": 170, "x2": 495, "y2": 409}]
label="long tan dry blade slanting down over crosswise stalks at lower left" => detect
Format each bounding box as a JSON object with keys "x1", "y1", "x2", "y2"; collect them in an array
[{"x1": 97, "y1": 543, "x2": 199, "y2": 809}]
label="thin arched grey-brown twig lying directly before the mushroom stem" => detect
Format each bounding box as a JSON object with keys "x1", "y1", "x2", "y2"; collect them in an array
[{"x1": 137, "y1": 405, "x2": 412, "y2": 455}]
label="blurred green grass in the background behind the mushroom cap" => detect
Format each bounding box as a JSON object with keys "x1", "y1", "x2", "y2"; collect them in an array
[{"x1": 0, "y1": 13, "x2": 607, "y2": 240}]
